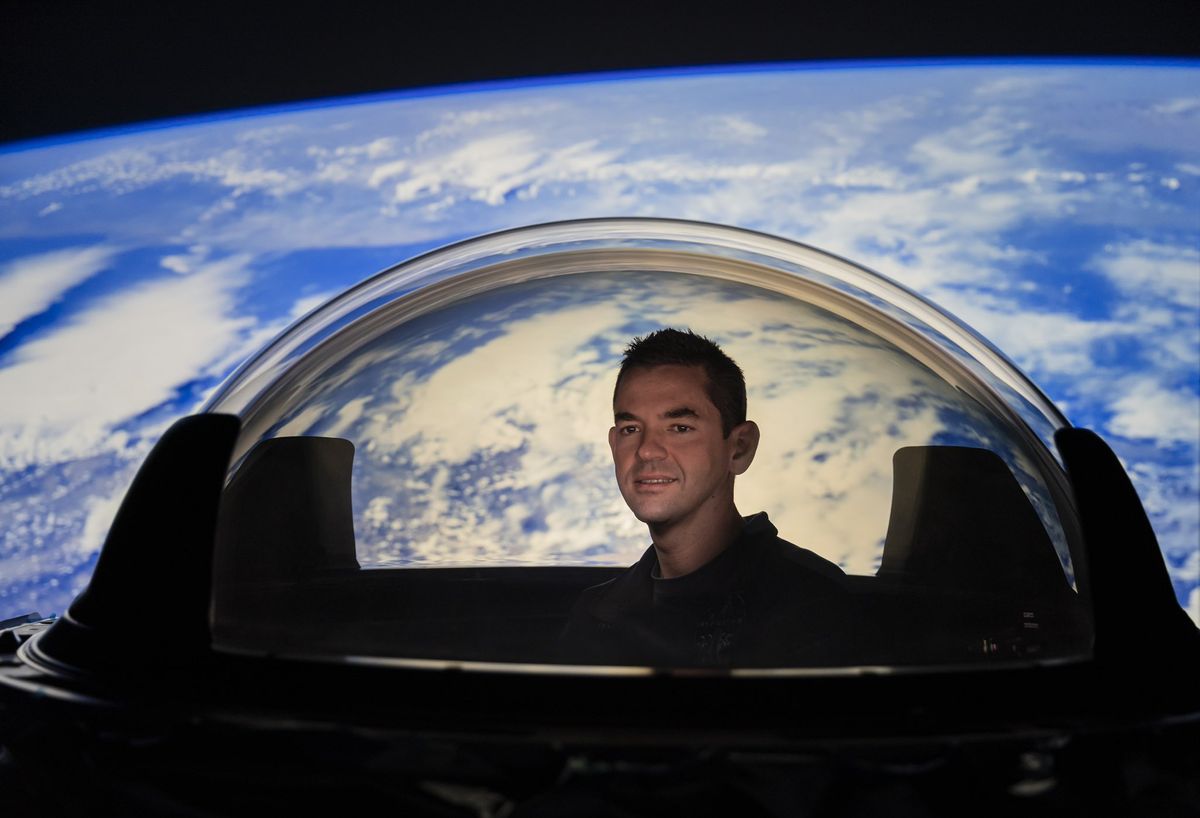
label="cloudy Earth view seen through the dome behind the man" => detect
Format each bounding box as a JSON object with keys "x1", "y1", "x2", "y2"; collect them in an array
[{"x1": 234, "y1": 272, "x2": 1069, "y2": 575}]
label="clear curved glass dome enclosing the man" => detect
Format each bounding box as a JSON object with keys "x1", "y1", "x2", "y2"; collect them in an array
[{"x1": 206, "y1": 219, "x2": 1091, "y2": 672}]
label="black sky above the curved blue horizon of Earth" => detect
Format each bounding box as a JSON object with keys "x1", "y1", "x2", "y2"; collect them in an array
[{"x1": 0, "y1": 0, "x2": 1200, "y2": 142}]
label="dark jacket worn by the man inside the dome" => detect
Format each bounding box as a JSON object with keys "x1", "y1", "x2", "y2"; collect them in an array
[{"x1": 560, "y1": 513, "x2": 864, "y2": 667}]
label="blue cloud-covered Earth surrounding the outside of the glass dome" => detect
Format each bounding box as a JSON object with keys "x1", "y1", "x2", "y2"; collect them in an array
[{"x1": 0, "y1": 61, "x2": 1200, "y2": 622}]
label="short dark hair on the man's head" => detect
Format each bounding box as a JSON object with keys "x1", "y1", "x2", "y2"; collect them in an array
[{"x1": 613, "y1": 327, "x2": 746, "y2": 438}]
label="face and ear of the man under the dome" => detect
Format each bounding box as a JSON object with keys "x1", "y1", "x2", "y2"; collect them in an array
[{"x1": 608, "y1": 366, "x2": 752, "y2": 527}]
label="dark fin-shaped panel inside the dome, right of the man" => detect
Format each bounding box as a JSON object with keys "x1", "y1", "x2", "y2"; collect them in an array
[{"x1": 857, "y1": 446, "x2": 1090, "y2": 664}]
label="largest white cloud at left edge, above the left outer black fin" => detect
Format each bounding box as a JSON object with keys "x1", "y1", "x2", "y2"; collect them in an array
[{"x1": 0, "y1": 257, "x2": 252, "y2": 468}]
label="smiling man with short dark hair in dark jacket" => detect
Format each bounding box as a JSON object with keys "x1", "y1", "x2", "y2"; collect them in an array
[{"x1": 562, "y1": 329, "x2": 859, "y2": 667}]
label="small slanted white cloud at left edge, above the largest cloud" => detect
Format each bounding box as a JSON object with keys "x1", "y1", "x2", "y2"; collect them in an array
[{"x1": 0, "y1": 246, "x2": 115, "y2": 338}]
